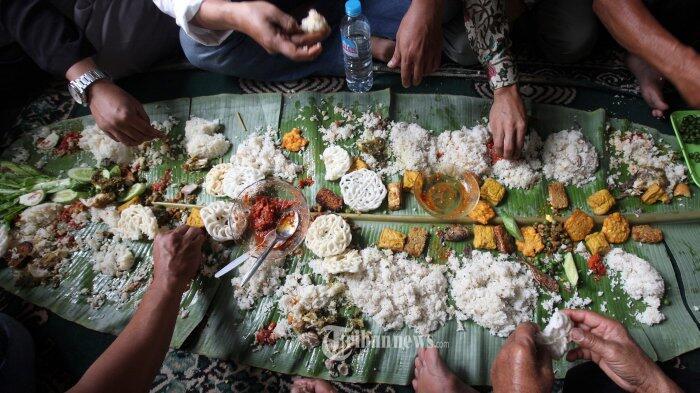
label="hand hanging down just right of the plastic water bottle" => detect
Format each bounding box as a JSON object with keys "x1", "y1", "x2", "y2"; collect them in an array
[{"x1": 387, "y1": 0, "x2": 443, "y2": 87}]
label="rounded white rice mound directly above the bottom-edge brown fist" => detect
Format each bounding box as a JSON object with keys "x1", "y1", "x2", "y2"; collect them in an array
[{"x1": 448, "y1": 250, "x2": 537, "y2": 337}]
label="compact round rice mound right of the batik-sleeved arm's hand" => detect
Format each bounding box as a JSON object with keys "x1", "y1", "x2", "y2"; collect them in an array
[{"x1": 542, "y1": 130, "x2": 598, "y2": 187}]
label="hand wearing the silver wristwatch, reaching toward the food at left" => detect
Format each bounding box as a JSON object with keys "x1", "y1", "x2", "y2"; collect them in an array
[{"x1": 88, "y1": 80, "x2": 164, "y2": 146}]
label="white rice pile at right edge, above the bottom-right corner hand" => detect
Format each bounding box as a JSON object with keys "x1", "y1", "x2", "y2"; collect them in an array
[{"x1": 605, "y1": 248, "x2": 666, "y2": 325}]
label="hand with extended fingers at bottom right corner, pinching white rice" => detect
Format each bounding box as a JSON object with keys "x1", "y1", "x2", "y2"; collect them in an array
[{"x1": 563, "y1": 310, "x2": 681, "y2": 392}]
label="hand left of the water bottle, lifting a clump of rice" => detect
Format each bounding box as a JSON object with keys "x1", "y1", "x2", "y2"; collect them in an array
[{"x1": 231, "y1": 1, "x2": 330, "y2": 61}]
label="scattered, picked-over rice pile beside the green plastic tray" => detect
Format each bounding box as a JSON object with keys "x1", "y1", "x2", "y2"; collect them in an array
[{"x1": 608, "y1": 130, "x2": 686, "y2": 195}]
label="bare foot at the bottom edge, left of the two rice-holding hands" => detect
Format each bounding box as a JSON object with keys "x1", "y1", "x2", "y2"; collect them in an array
[{"x1": 412, "y1": 348, "x2": 476, "y2": 393}]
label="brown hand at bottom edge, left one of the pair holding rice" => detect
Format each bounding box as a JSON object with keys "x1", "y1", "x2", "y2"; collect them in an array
[{"x1": 491, "y1": 322, "x2": 554, "y2": 392}]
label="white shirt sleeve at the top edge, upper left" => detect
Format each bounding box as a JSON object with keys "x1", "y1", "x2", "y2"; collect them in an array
[{"x1": 153, "y1": 0, "x2": 233, "y2": 46}]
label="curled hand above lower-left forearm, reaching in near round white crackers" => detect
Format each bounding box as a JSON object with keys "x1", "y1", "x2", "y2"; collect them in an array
[{"x1": 153, "y1": 225, "x2": 206, "y2": 294}]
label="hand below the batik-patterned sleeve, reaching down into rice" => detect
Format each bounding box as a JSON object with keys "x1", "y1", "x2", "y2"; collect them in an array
[{"x1": 489, "y1": 85, "x2": 527, "y2": 160}]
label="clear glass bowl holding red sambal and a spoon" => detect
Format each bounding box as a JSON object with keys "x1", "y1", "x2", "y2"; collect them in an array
[{"x1": 229, "y1": 179, "x2": 310, "y2": 259}]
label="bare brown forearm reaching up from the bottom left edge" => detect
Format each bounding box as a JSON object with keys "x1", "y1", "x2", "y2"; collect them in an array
[{"x1": 71, "y1": 281, "x2": 181, "y2": 393}]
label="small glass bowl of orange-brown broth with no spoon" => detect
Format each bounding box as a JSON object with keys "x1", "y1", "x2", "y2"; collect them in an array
[{"x1": 413, "y1": 172, "x2": 481, "y2": 220}]
